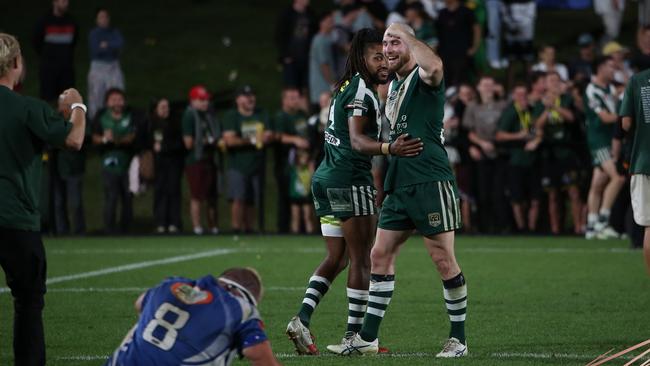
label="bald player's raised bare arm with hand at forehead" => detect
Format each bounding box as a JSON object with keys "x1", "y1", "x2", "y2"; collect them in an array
[{"x1": 386, "y1": 23, "x2": 443, "y2": 86}]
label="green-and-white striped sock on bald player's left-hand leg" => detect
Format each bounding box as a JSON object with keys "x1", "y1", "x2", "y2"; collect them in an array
[{"x1": 359, "y1": 274, "x2": 395, "y2": 342}]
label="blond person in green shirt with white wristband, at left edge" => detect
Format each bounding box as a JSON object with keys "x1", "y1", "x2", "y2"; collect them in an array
[{"x1": 0, "y1": 33, "x2": 86, "y2": 365}]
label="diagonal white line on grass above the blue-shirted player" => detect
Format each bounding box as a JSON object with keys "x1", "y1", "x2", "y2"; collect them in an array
[{"x1": 0, "y1": 249, "x2": 237, "y2": 292}]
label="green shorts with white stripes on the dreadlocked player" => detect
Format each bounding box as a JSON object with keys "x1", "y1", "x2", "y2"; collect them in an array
[{"x1": 311, "y1": 178, "x2": 378, "y2": 218}]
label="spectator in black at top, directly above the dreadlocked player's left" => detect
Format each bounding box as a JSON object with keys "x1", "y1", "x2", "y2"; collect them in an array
[{"x1": 275, "y1": 0, "x2": 318, "y2": 91}]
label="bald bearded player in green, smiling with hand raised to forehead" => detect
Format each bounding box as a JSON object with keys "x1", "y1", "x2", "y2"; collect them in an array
[{"x1": 328, "y1": 23, "x2": 467, "y2": 357}]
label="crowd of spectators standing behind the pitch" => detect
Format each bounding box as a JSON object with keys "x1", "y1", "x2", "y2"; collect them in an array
[{"x1": 34, "y1": 0, "x2": 650, "y2": 244}]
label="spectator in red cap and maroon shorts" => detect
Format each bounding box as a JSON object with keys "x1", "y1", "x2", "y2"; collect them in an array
[{"x1": 181, "y1": 85, "x2": 221, "y2": 235}]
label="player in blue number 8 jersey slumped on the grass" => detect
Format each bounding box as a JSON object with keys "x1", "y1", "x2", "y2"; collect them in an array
[{"x1": 106, "y1": 268, "x2": 279, "y2": 366}]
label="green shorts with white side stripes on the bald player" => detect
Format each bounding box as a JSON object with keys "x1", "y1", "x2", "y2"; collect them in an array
[{"x1": 378, "y1": 181, "x2": 462, "y2": 236}]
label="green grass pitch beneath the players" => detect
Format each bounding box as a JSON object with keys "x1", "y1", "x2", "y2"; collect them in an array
[{"x1": 0, "y1": 236, "x2": 650, "y2": 365}]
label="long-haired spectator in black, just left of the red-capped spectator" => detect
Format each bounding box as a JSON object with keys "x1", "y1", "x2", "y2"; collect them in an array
[{"x1": 150, "y1": 98, "x2": 185, "y2": 234}]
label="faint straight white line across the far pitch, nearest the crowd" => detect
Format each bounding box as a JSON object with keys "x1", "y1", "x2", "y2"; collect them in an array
[{"x1": 47, "y1": 247, "x2": 637, "y2": 255}]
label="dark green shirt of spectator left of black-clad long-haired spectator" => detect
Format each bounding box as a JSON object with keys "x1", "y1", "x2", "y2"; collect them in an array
[{"x1": 98, "y1": 109, "x2": 135, "y2": 175}]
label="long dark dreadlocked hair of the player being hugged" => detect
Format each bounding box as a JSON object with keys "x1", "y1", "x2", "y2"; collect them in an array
[{"x1": 334, "y1": 28, "x2": 383, "y2": 94}]
